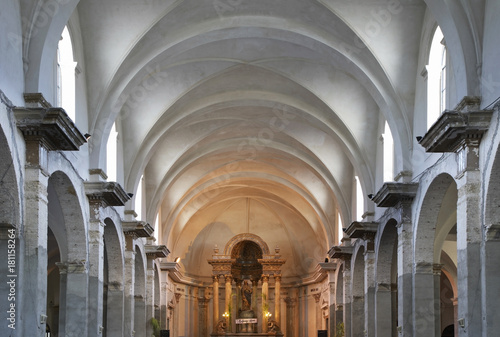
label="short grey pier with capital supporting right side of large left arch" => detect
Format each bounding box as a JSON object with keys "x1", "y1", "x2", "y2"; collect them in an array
[{"x1": 56, "y1": 262, "x2": 89, "y2": 336}]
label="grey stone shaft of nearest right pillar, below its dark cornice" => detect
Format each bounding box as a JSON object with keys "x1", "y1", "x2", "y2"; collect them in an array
[{"x1": 457, "y1": 139, "x2": 484, "y2": 337}]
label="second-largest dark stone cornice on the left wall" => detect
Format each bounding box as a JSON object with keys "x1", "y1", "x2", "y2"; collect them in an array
[{"x1": 84, "y1": 181, "x2": 130, "y2": 207}]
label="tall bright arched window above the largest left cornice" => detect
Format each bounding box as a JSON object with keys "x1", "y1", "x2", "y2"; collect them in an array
[{"x1": 56, "y1": 27, "x2": 76, "y2": 121}]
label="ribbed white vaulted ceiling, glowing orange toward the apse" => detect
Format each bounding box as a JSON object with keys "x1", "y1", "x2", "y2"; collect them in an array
[{"x1": 77, "y1": 0, "x2": 425, "y2": 282}]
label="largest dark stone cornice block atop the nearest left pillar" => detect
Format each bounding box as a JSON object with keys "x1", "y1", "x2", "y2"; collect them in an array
[{"x1": 13, "y1": 103, "x2": 87, "y2": 151}]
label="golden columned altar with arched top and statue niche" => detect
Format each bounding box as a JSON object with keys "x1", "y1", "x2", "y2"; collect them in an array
[{"x1": 208, "y1": 233, "x2": 285, "y2": 337}]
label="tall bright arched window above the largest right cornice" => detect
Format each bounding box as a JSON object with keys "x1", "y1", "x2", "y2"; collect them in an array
[{"x1": 426, "y1": 26, "x2": 447, "y2": 128}]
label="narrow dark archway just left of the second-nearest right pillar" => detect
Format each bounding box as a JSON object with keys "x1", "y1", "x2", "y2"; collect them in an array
[{"x1": 375, "y1": 219, "x2": 398, "y2": 336}]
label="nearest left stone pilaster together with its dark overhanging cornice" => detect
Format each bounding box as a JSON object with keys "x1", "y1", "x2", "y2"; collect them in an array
[{"x1": 13, "y1": 101, "x2": 85, "y2": 337}]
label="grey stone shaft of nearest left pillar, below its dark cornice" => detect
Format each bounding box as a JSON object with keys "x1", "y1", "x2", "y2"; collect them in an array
[{"x1": 21, "y1": 141, "x2": 49, "y2": 337}]
